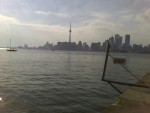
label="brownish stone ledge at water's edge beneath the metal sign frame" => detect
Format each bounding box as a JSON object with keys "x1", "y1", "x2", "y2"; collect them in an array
[{"x1": 103, "y1": 72, "x2": 150, "y2": 113}]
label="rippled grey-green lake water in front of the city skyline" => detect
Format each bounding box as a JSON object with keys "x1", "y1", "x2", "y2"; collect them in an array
[{"x1": 0, "y1": 50, "x2": 150, "y2": 113}]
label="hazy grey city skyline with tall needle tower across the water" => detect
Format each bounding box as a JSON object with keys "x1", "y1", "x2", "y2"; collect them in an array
[{"x1": 17, "y1": 33, "x2": 150, "y2": 53}]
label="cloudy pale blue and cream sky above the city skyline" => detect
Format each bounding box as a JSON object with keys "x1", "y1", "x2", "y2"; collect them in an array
[{"x1": 0, "y1": 0, "x2": 150, "y2": 47}]
